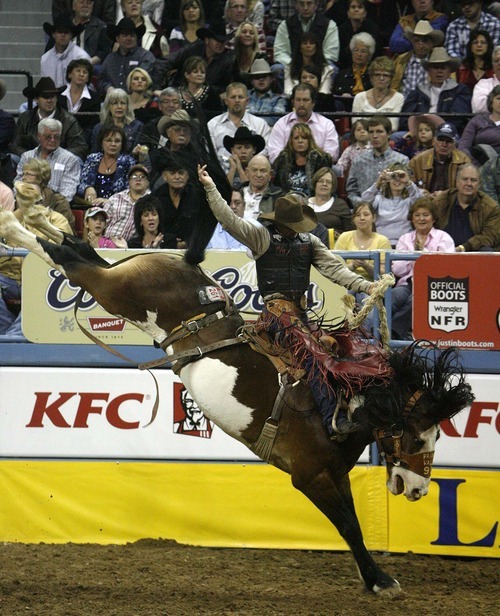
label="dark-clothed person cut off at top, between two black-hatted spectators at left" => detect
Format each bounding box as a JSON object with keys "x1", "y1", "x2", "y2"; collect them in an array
[{"x1": 66, "y1": 0, "x2": 111, "y2": 66}]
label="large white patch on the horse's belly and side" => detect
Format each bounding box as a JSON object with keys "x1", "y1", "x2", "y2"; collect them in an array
[{"x1": 181, "y1": 357, "x2": 253, "y2": 441}]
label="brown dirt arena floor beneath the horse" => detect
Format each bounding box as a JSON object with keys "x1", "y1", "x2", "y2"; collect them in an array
[{"x1": 0, "y1": 540, "x2": 500, "y2": 616}]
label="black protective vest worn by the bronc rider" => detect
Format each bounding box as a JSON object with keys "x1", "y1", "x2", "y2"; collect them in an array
[{"x1": 256, "y1": 223, "x2": 313, "y2": 303}]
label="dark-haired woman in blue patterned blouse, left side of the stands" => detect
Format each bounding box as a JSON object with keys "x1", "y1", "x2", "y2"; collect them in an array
[{"x1": 77, "y1": 124, "x2": 136, "y2": 205}]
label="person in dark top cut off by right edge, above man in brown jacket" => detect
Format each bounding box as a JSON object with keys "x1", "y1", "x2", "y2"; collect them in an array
[{"x1": 458, "y1": 85, "x2": 500, "y2": 163}]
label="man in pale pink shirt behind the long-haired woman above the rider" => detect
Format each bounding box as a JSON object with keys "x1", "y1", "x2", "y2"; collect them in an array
[{"x1": 268, "y1": 83, "x2": 339, "y2": 163}]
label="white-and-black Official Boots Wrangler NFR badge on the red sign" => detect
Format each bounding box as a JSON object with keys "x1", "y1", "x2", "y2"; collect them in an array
[{"x1": 427, "y1": 276, "x2": 469, "y2": 332}]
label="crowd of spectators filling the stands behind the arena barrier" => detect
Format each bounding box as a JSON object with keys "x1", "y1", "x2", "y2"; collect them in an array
[{"x1": 0, "y1": 0, "x2": 500, "y2": 338}]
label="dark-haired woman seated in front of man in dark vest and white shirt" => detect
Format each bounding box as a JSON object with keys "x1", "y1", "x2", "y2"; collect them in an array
[{"x1": 284, "y1": 32, "x2": 335, "y2": 96}]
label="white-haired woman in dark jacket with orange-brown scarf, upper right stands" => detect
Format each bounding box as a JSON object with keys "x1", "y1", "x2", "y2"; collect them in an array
[{"x1": 332, "y1": 32, "x2": 375, "y2": 111}]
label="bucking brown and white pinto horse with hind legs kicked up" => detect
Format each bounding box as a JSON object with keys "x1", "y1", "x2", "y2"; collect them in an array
[{"x1": 0, "y1": 190, "x2": 472, "y2": 595}]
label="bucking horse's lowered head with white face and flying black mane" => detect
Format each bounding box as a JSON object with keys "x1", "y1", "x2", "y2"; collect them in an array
[{"x1": 369, "y1": 343, "x2": 474, "y2": 501}]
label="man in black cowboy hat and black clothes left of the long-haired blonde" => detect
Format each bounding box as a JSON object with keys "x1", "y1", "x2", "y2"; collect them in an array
[{"x1": 153, "y1": 21, "x2": 234, "y2": 93}]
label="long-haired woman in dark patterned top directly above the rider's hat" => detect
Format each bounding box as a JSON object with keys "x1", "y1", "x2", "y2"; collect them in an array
[{"x1": 273, "y1": 122, "x2": 332, "y2": 196}]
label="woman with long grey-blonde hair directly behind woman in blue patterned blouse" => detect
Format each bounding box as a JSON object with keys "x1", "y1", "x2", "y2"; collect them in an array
[{"x1": 91, "y1": 88, "x2": 143, "y2": 152}]
